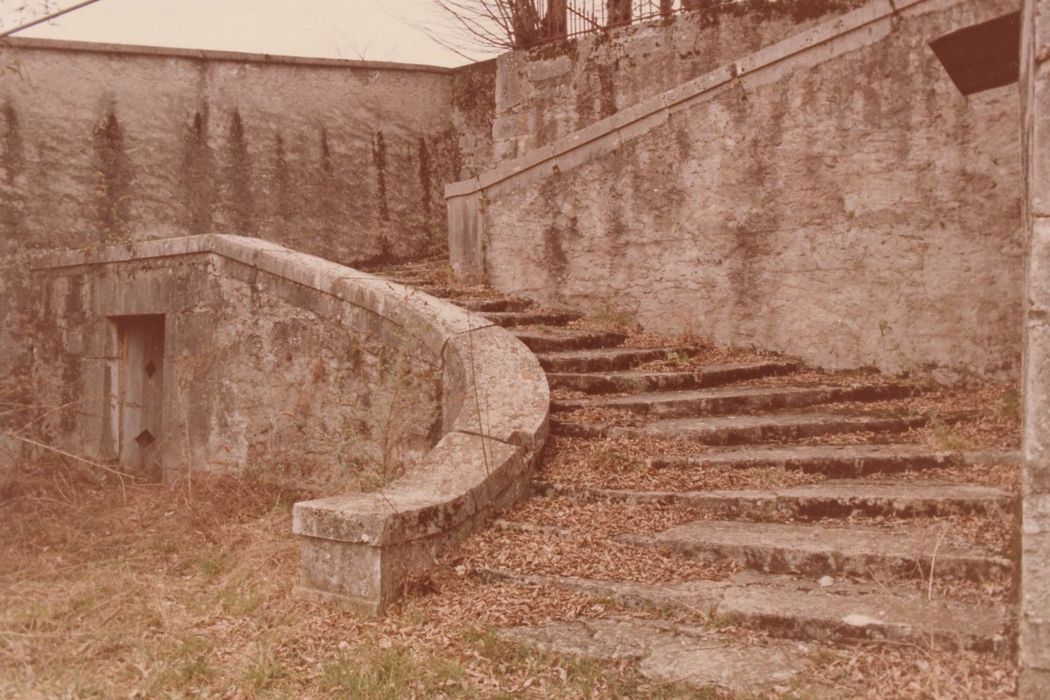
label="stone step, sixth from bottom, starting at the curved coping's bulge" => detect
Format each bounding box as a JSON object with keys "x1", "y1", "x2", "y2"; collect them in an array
[{"x1": 551, "y1": 413, "x2": 928, "y2": 445}]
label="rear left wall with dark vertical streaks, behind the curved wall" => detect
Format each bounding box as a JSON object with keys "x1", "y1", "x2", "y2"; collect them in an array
[{"x1": 0, "y1": 40, "x2": 458, "y2": 411}]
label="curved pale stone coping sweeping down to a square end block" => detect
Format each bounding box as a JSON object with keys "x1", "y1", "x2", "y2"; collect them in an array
[{"x1": 34, "y1": 234, "x2": 550, "y2": 613}]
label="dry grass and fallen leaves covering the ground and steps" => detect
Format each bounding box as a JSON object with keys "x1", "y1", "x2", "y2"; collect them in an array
[{"x1": 0, "y1": 266, "x2": 1016, "y2": 699}]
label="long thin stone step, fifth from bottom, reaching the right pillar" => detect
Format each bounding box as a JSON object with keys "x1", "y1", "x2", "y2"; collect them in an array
[{"x1": 647, "y1": 445, "x2": 1021, "y2": 479}]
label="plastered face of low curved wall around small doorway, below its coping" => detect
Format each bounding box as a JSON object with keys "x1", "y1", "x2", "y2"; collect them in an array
[{"x1": 34, "y1": 239, "x2": 442, "y2": 492}]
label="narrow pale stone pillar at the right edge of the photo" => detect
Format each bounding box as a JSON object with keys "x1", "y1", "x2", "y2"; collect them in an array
[{"x1": 1019, "y1": 0, "x2": 1050, "y2": 698}]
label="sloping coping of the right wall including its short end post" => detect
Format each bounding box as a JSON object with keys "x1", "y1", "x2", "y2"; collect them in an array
[{"x1": 445, "y1": 0, "x2": 932, "y2": 281}]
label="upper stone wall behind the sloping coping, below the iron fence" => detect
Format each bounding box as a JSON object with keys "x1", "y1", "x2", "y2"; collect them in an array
[{"x1": 491, "y1": 0, "x2": 865, "y2": 160}]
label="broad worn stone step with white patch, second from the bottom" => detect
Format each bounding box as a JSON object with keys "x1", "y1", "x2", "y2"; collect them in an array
[{"x1": 480, "y1": 569, "x2": 1009, "y2": 654}]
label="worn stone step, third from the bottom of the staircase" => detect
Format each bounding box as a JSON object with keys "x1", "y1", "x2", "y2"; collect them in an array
[{"x1": 622, "y1": 521, "x2": 1013, "y2": 581}]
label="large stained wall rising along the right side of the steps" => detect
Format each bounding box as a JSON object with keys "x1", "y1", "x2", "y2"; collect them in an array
[{"x1": 466, "y1": 0, "x2": 1022, "y2": 380}]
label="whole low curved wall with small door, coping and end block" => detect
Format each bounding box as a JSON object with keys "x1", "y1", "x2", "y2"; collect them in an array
[{"x1": 34, "y1": 235, "x2": 549, "y2": 611}]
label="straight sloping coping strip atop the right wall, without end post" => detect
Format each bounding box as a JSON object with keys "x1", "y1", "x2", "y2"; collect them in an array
[{"x1": 445, "y1": 0, "x2": 941, "y2": 199}]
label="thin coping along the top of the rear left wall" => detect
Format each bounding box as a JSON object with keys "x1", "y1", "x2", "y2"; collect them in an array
[{"x1": 0, "y1": 37, "x2": 455, "y2": 75}]
